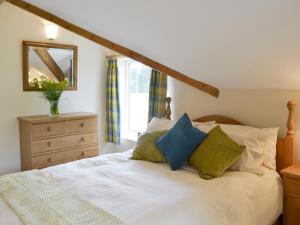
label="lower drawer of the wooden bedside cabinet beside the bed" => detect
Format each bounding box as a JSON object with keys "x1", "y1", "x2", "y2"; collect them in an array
[{"x1": 284, "y1": 196, "x2": 300, "y2": 225}]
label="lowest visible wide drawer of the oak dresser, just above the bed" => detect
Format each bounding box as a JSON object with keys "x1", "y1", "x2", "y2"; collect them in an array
[{"x1": 32, "y1": 146, "x2": 98, "y2": 169}]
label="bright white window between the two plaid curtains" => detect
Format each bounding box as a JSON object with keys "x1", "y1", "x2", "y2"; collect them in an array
[{"x1": 118, "y1": 58, "x2": 150, "y2": 140}]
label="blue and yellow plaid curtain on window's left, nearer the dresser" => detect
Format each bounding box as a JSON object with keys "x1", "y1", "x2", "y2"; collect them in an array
[{"x1": 105, "y1": 59, "x2": 121, "y2": 144}]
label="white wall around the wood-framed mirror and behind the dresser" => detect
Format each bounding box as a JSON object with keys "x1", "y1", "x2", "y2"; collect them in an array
[{"x1": 0, "y1": 2, "x2": 106, "y2": 174}]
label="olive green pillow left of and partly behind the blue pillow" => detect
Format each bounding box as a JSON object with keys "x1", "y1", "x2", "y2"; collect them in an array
[{"x1": 131, "y1": 130, "x2": 167, "y2": 163}]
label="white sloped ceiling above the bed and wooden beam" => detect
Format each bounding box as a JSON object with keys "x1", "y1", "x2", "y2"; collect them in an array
[{"x1": 27, "y1": 0, "x2": 300, "y2": 89}]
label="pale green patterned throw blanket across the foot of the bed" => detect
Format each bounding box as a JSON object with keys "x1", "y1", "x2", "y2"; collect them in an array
[{"x1": 0, "y1": 170, "x2": 124, "y2": 225}]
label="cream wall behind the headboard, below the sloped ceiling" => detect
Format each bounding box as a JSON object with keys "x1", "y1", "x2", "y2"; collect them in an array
[{"x1": 168, "y1": 78, "x2": 300, "y2": 161}]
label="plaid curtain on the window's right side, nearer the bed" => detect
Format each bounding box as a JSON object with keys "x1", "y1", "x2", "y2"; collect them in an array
[{"x1": 148, "y1": 69, "x2": 168, "y2": 121}]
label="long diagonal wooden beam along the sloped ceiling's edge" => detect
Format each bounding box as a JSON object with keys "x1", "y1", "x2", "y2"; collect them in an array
[{"x1": 6, "y1": 0, "x2": 219, "y2": 97}]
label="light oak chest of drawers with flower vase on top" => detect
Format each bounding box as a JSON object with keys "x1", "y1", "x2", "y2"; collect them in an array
[{"x1": 18, "y1": 113, "x2": 98, "y2": 171}]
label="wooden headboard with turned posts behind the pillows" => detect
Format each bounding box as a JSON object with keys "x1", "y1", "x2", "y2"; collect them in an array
[{"x1": 166, "y1": 98, "x2": 296, "y2": 172}]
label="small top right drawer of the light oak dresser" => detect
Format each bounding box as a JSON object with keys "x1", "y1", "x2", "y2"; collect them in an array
[{"x1": 68, "y1": 118, "x2": 97, "y2": 133}]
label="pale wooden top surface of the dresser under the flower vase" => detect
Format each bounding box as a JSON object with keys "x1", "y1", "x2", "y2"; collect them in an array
[{"x1": 18, "y1": 112, "x2": 97, "y2": 123}]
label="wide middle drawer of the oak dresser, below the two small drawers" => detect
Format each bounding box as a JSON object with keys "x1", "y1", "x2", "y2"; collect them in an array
[{"x1": 32, "y1": 132, "x2": 98, "y2": 154}]
